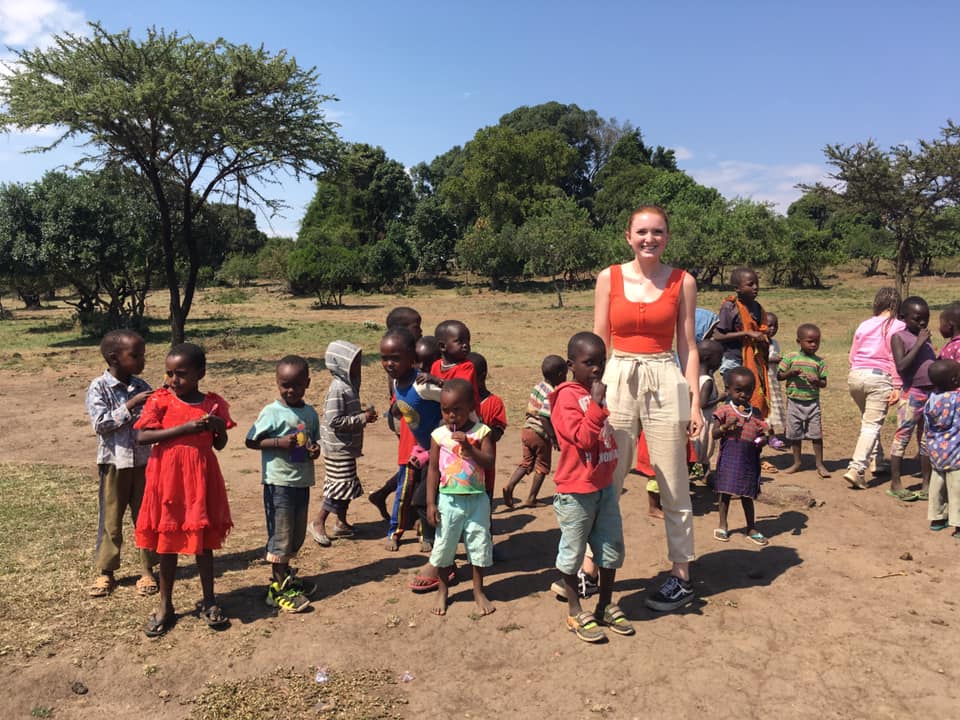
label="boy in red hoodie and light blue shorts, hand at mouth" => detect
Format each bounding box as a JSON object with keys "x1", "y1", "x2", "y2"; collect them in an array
[{"x1": 550, "y1": 332, "x2": 634, "y2": 643}]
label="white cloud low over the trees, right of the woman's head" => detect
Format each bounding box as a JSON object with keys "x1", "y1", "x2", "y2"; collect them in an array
[{"x1": 687, "y1": 160, "x2": 828, "y2": 213}]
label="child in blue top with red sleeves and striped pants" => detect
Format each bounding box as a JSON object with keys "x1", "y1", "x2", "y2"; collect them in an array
[{"x1": 380, "y1": 327, "x2": 440, "y2": 552}]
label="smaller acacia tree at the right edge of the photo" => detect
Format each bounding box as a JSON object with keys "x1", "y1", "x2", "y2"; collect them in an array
[{"x1": 801, "y1": 120, "x2": 960, "y2": 294}]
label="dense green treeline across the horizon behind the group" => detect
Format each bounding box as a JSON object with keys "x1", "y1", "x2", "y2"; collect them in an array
[{"x1": 0, "y1": 102, "x2": 960, "y2": 331}]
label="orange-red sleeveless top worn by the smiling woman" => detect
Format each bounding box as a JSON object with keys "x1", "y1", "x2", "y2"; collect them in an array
[{"x1": 610, "y1": 265, "x2": 686, "y2": 354}]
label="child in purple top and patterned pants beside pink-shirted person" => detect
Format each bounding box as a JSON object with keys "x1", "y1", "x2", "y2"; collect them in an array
[{"x1": 887, "y1": 296, "x2": 937, "y2": 501}]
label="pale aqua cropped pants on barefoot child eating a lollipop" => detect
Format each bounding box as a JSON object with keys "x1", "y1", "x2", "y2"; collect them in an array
[{"x1": 430, "y1": 492, "x2": 493, "y2": 568}]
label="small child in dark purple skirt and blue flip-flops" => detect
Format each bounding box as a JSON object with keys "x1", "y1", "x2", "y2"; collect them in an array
[{"x1": 713, "y1": 368, "x2": 770, "y2": 545}]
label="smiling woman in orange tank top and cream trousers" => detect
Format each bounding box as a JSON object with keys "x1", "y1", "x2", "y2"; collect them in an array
[{"x1": 593, "y1": 205, "x2": 703, "y2": 611}]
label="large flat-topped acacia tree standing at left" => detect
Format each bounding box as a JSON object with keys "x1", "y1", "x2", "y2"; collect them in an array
[{"x1": 0, "y1": 23, "x2": 338, "y2": 342}]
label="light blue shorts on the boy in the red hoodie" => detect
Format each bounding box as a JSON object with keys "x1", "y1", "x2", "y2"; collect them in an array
[{"x1": 553, "y1": 483, "x2": 625, "y2": 575}]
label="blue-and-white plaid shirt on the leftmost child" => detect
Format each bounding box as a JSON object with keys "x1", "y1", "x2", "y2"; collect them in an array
[{"x1": 87, "y1": 370, "x2": 152, "y2": 469}]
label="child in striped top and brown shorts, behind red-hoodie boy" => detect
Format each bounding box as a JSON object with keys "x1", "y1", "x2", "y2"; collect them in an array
[{"x1": 503, "y1": 355, "x2": 567, "y2": 510}]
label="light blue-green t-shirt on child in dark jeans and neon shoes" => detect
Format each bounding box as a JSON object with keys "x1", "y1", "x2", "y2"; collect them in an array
[{"x1": 247, "y1": 400, "x2": 320, "y2": 487}]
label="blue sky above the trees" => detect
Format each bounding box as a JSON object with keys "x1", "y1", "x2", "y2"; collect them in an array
[{"x1": 0, "y1": 0, "x2": 960, "y2": 235}]
